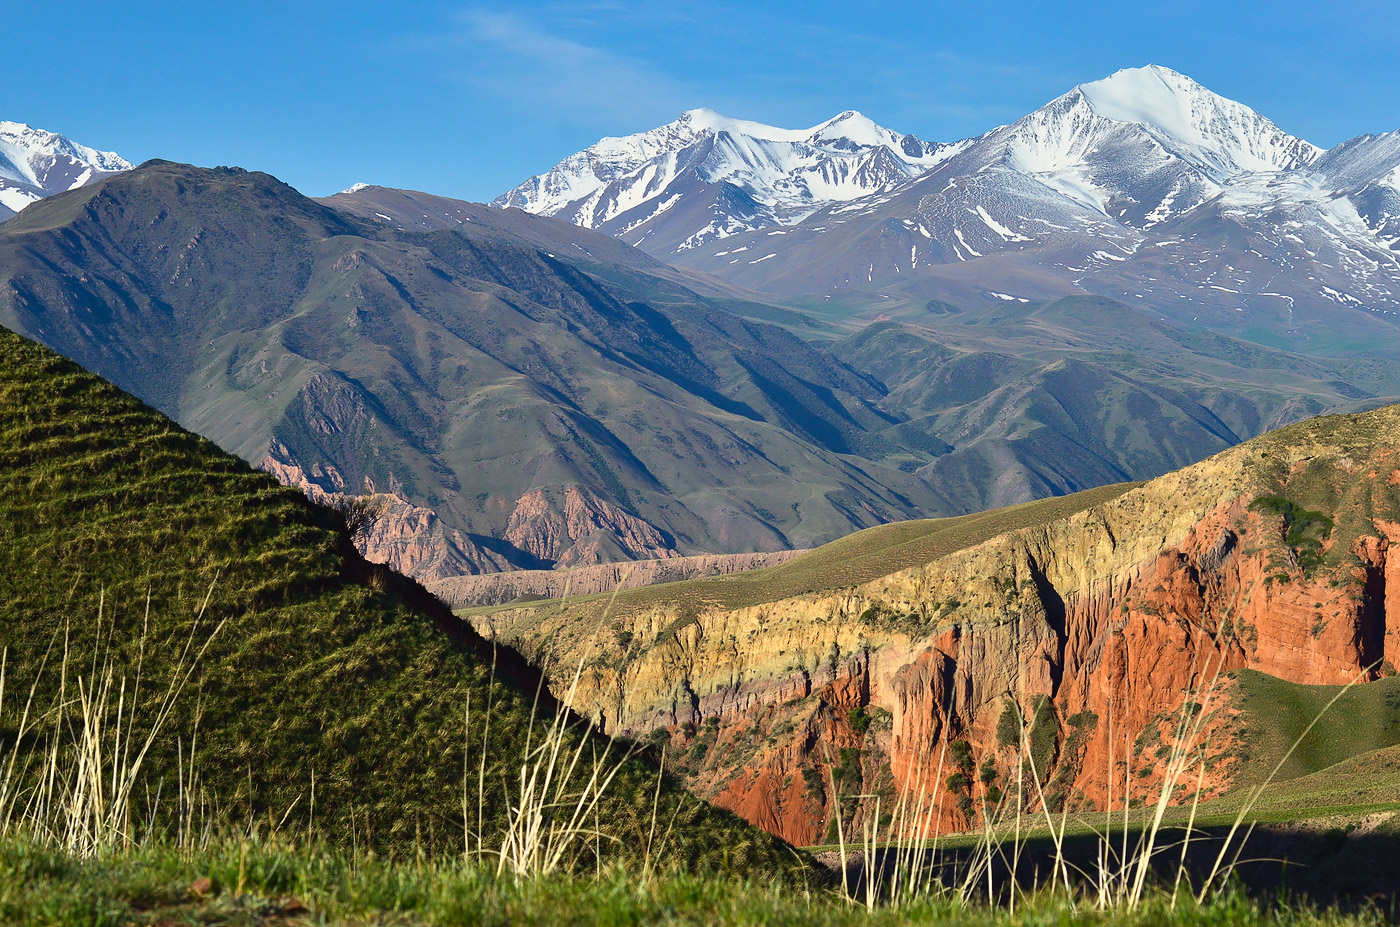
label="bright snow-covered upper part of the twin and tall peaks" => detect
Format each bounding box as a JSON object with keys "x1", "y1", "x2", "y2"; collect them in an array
[{"x1": 494, "y1": 64, "x2": 1322, "y2": 253}]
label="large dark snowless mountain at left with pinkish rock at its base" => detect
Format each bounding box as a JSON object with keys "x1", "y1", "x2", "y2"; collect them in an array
[{"x1": 0, "y1": 164, "x2": 952, "y2": 580}]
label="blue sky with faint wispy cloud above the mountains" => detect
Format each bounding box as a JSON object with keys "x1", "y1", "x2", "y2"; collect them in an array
[{"x1": 0, "y1": 0, "x2": 1400, "y2": 200}]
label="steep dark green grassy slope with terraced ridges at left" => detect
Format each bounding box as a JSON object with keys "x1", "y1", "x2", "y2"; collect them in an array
[{"x1": 0, "y1": 329, "x2": 791, "y2": 871}]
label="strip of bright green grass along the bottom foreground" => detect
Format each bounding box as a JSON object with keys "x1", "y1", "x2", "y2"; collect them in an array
[{"x1": 0, "y1": 842, "x2": 1386, "y2": 927}]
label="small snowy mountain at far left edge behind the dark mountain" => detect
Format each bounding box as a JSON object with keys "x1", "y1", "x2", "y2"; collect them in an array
[{"x1": 0, "y1": 122, "x2": 132, "y2": 221}]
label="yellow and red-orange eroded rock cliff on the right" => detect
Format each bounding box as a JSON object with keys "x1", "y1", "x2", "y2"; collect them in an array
[{"x1": 473, "y1": 407, "x2": 1400, "y2": 844}]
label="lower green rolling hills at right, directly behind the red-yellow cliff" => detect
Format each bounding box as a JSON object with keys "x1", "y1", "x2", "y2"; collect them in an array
[{"x1": 832, "y1": 297, "x2": 1400, "y2": 507}]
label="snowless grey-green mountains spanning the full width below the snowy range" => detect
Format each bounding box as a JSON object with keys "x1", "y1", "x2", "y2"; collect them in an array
[{"x1": 0, "y1": 162, "x2": 1400, "y2": 604}]
